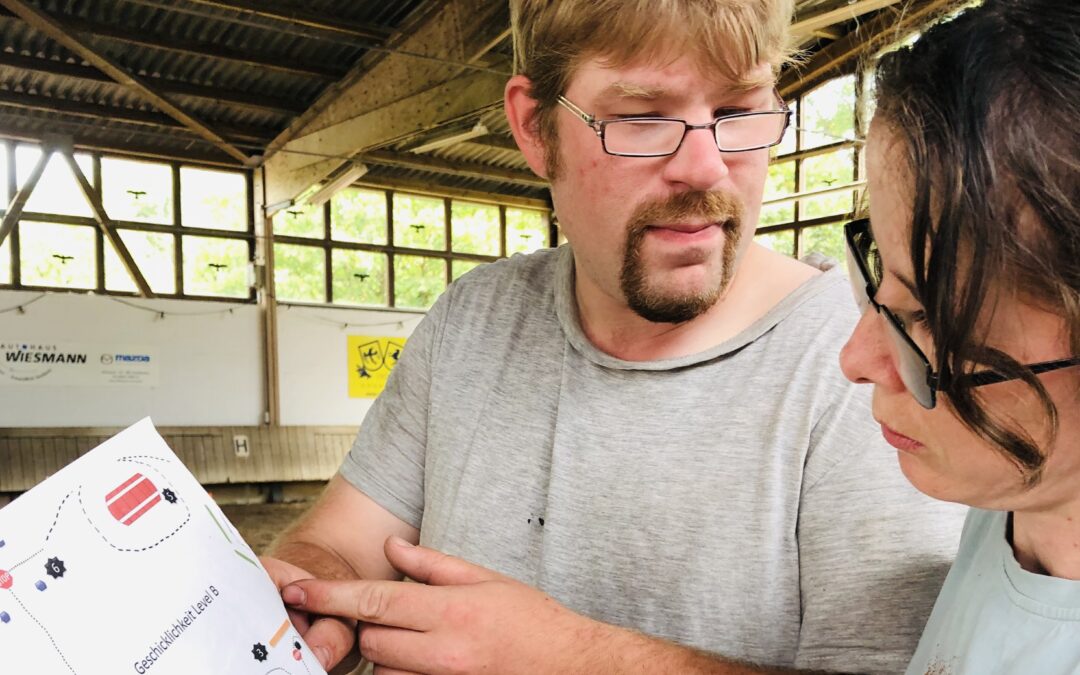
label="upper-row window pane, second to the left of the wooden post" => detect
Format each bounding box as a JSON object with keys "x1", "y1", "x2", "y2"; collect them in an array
[{"x1": 102, "y1": 157, "x2": 173, "y2": 225}]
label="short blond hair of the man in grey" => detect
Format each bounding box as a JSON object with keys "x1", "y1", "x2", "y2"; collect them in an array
[{"x1": 510, "y1": 0, "x2": 794, "y2": 173}]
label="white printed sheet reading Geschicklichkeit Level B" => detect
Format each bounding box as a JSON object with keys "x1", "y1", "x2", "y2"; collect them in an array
[{"x1": 0, "y1": 419, "x2": 325, "y2": 675}]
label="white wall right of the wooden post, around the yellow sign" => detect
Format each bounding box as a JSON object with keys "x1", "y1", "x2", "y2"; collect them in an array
[{"x1": 278, "y1": 306, "x2": 422, "y2": 426}]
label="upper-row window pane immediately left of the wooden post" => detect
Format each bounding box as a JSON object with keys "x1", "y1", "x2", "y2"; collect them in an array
[{"x1": 180, "y1": 166, "x2": 247, "y2": 231}]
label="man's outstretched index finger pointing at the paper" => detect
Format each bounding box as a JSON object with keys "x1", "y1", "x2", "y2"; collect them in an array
[{"x1": 282, "y1": 579, "x2": 443, "y2": 631}]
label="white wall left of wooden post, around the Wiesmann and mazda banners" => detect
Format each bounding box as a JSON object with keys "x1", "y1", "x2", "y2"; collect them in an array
[{"x1": 0, "y1": 292, "x2": 266, "y2": 427}]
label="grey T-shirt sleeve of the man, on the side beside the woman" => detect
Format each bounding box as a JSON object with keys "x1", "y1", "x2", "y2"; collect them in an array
[{"x1": 796, "y1": 387, "x2": 967, "y2": 673}]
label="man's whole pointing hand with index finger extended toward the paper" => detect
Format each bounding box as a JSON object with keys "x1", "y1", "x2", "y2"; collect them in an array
[{"x1": 282, "y1": 537, "x2": 609, "y2": 675}]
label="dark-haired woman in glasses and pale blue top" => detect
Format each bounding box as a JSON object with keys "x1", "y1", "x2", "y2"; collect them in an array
[{"x1": 840, "y1": 0, "x2": 1080, "y2": 675}]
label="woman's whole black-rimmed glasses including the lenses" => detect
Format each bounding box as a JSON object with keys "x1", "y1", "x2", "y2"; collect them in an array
[{"x1": 843, "y1": 218, "x2": 1080, "y2": 408}]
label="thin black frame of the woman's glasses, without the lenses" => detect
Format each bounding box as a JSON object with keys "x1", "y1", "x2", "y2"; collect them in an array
[{"x1": 843, "y1": 218, "x2": 1080, "y2": 410}]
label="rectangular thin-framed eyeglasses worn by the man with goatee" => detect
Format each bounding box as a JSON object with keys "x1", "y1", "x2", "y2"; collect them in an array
[{"x1": 558, "y1": 94, "x2": 792, "y2": 157}]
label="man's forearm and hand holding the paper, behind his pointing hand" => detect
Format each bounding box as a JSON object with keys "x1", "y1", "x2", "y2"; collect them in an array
[{"x1": 261, "y1": 476, "x2": 419, "y2": 670}]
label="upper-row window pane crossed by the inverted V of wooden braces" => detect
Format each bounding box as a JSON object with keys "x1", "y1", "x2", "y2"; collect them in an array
[{"x1": 15, "y1": 145, "x2": 94, "y2": 217}]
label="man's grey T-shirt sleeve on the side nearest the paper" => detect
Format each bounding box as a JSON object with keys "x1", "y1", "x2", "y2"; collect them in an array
[{"x1": 340, "y1": 284, "x2": 455, "y2": 528}]
